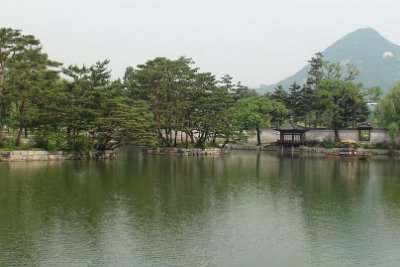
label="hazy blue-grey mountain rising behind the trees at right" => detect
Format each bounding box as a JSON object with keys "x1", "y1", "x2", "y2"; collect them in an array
[{"x1": 257, "y1": 28, "x2": 400, "y2": 94}]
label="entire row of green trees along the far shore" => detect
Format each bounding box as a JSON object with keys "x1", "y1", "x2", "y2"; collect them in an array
[{"x1": 0, "y1": 28, "x2": 399, "y2": 152}]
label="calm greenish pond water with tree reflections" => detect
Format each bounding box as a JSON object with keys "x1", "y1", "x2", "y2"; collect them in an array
[{"x1": 0, "y1": 150, "x2": 400, "y2": 266}]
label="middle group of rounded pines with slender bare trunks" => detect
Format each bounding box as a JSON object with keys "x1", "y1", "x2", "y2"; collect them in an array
[{"x1": 124, "y1": 57, "x2": 282, "y2": 148}]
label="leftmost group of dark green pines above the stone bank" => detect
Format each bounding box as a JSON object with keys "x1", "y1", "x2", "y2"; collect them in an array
[{"x1": 0, "y1": 28, "x2": 155, "y2": 153}]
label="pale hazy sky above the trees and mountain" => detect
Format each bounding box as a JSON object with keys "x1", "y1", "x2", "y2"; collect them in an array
[{"x1": 0, "y1": 0, "x2": 400, "y2": 87}]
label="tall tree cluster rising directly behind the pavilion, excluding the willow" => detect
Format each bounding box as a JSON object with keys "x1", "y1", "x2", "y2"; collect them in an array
[{"x1": 269, "y1": 53, "x2": 379, "y2": 139}]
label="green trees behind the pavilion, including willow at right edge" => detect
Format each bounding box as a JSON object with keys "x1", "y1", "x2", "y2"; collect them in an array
[{"x1": 267, "y1": 52, "x2": 400, "y2": 144}]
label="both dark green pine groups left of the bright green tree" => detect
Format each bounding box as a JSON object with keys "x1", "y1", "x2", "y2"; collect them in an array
[{"x1": 0, "y1": 28, "x2": 285, "y2": 152}]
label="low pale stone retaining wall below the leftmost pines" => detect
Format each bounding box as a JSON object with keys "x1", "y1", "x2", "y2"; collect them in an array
[{"x1": 0, "y1": 150, "x2": 116, "y2": 161}]
